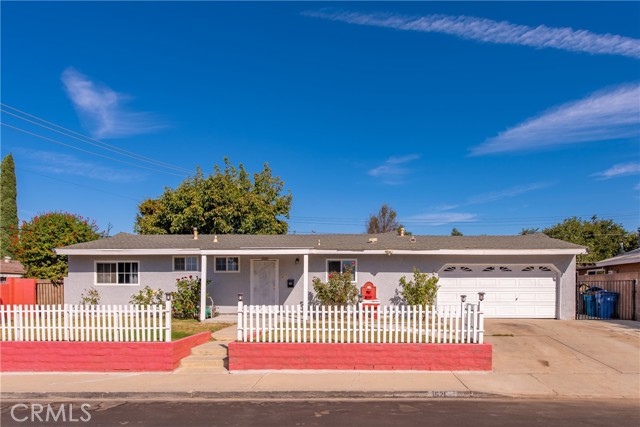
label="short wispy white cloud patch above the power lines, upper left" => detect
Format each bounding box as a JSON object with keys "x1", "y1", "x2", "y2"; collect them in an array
[{"x1": 61, "y1": 68, "x2": 166, "y2": 138}]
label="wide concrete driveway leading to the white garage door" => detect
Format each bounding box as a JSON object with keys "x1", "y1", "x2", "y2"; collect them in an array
[{"x1": 458, "y1": 319, "x2": 640, "y2": 398}]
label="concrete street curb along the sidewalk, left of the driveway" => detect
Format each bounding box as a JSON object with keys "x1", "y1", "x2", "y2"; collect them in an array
[{"x1": 0, "y1": 390, "x2": 508, "y2": 401}]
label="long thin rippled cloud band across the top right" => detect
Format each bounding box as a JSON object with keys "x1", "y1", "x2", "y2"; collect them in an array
[{"x1": 303, "y1": 11, "x2": 640, "y2": 58}]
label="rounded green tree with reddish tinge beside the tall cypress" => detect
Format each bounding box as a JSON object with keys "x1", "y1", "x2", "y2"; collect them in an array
[{"x1": 13, "y1": 212, "x2": 103, "y2": 283}]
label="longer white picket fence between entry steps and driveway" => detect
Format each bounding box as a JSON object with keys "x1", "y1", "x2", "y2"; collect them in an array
[{"x1": 237, "y1": 301, "x2": 484, "y2": 344}]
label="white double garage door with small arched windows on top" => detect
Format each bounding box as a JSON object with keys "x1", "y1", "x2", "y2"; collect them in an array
[{"x1": 437, "y1": 265, "x2": 557, "y2": 318}]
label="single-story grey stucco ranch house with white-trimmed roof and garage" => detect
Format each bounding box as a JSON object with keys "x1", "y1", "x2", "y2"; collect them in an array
[{"x1": 57, "y1": 232, "x2": 585, "y2": 319}]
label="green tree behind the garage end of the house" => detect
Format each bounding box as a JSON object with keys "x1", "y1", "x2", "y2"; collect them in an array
[{"x1": 542, "y1": 215, "x2": 638, "y2": 263}]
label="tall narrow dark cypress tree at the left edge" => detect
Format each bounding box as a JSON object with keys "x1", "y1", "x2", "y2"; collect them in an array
[{"x1": 0, "y1": 153, "x2": 18, "y2": 258}]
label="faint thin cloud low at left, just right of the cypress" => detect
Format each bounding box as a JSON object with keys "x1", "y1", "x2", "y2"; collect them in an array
[{"x1": 20, "y1": 150, "x2": 143, "y2": 183}]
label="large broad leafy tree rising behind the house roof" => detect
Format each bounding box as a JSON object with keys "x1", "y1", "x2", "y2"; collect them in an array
[{"x1": 134, "y1": 157, "x2": 292, "y2": 234}]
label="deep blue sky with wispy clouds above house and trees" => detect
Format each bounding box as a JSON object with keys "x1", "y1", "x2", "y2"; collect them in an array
[{"x1": 0, "y1": 2, "x2": 640, "y2": 235}]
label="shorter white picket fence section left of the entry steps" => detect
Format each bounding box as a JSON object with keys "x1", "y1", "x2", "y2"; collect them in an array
[{"x1": 0, "y1": 301, "x2": 171, "y2": 342}]
